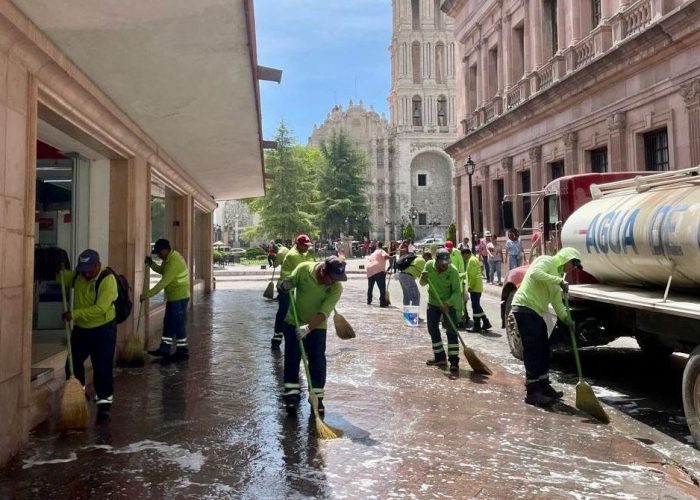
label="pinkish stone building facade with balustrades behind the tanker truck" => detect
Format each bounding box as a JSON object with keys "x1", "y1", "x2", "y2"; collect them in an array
[{"x1": 442, "y1": 0, "x2": 700, "y2": 244}]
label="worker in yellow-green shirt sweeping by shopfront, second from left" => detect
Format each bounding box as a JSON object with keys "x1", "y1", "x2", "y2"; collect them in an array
[{"x1": 141, "y1": 238, "x2": 190, "y2": 360}]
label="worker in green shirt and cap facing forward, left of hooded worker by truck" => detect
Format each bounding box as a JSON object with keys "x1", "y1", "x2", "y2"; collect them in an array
[{"x1": 420, "y1": 248, "x2": 462, "y2": 380}]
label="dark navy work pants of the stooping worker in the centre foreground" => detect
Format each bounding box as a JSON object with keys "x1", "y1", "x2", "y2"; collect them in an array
[{"x1": 282, "y1": 322, "x2": 326, "y2": 401}]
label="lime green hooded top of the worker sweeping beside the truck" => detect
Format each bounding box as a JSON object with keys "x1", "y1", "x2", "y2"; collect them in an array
[{"x1": 512, "y1": 247, "x2": 581, "y2": 321}]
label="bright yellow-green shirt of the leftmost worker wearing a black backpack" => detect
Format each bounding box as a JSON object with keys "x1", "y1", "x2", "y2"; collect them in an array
[{"x1": 56, "y1": 265, "x2": 118, "y2": 328}]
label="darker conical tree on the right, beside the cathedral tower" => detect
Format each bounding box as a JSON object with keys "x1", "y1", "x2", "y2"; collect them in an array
[{"x1": 315, "y1": 129, "x2": 370, "y2": 238}]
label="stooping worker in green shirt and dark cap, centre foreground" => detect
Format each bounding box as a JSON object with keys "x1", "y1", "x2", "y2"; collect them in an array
[{"x1": 279, "y1": 255, "x2": 348, "y2": 417}]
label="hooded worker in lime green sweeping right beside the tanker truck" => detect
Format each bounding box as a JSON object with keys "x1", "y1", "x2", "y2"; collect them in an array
[{"x1": 511, "y1": 247, "x2": 583, "y2": 407}]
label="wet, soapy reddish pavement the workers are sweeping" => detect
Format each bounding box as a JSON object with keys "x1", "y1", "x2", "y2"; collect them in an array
[{"x1": 0, "y1": 276, "x2": 700, "y2": 499}]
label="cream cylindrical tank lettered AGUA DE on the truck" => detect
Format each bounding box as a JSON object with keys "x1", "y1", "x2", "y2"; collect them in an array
[{"x1": 562, "y1": 183, "x2": 700, "y2": 288}]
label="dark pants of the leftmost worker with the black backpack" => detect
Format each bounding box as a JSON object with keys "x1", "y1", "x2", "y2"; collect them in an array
[{"x1": 66, "y1": 320, "x2": 117, "y2": 405}]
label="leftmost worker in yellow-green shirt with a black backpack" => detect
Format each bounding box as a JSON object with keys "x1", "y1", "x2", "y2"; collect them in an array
[{"x1": 57, "y1": 249, "x2": 118, "y2": 420}]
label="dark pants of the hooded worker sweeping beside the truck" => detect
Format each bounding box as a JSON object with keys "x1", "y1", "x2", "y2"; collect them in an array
[{"x1": 513, "y1": 306, "x2": 550, "y2": 386}]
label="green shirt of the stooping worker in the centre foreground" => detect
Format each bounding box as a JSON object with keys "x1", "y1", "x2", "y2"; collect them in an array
[{"x1": 285, "y1": 262, "x2": 343, "y2": 328}]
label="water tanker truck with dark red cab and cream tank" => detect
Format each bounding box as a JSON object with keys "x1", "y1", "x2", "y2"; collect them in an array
[{"x1": 501, "y1": 166, "x2": 700, "y2": 447}]
